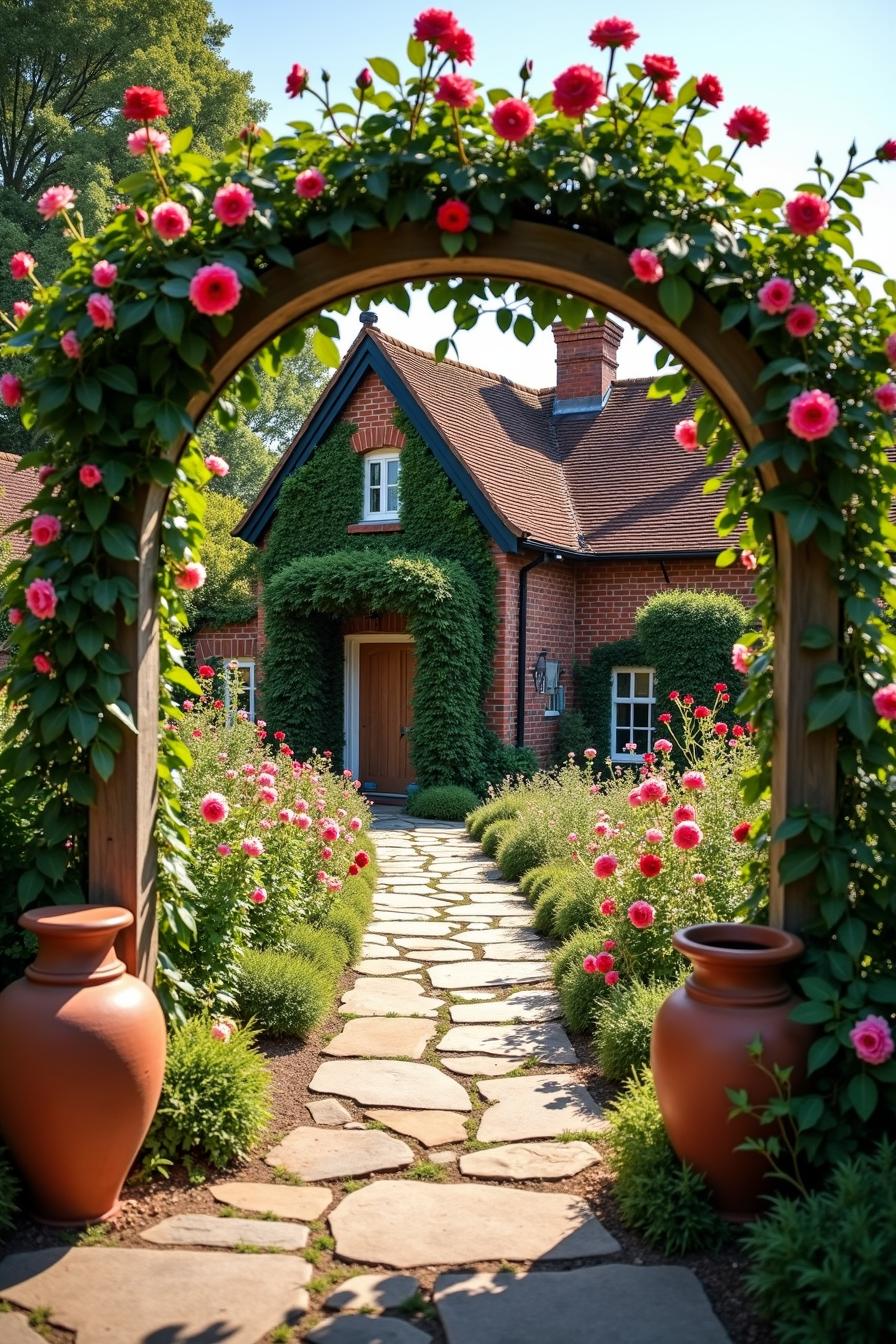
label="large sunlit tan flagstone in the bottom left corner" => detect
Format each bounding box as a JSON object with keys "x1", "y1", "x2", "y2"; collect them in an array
[{"x1": 0, "y1": 1246, "x2": 313, "y2": 1344}]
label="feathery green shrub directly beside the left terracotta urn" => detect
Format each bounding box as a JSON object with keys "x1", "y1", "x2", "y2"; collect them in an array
[{"x1": 144, "y1": 1015, "x2": 271, "y2": 1171}]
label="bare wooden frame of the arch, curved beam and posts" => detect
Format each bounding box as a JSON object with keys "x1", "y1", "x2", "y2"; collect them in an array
[{"x1": 89, "y1": 222, "x2": 838, "y2": 977}]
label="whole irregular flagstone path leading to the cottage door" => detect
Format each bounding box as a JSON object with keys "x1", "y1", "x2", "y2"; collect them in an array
[{"x1": 0, "y1": 813, "x2": 727, "y2": 1344}]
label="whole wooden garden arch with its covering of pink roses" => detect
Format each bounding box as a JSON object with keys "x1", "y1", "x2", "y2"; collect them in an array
[{"x1": 0, "y1": 11, "x2": 896, "y2": 1134}]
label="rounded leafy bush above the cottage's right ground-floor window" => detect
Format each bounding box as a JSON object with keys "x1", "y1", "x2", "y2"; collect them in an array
[{"x1": 635, "y1": 589, "x2": 751, "y2": 708}]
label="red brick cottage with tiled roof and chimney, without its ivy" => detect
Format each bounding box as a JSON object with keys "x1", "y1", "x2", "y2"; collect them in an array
[{"x1": 196, "y1": 314, "x2": 750, "y2": 794}]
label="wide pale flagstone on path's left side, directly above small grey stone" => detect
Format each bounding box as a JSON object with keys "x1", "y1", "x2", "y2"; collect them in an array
[{"x1": 308, "y1": 1059, "x2": 472, "y2": 1110}]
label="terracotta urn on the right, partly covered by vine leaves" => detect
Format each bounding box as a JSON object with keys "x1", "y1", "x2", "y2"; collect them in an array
[{"x1": 650, "y1": 923, "x2": 815, "y2": 1220}]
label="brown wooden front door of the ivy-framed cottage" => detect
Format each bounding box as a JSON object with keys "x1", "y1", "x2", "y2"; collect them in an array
[{"x1": 359, "y1": 642, "x2": 416, "y2": 793}]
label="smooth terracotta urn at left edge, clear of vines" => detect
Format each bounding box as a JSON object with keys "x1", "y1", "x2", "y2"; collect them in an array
[{"x1": 0, "y1": 905, "x2": 165, "y2": 1224}]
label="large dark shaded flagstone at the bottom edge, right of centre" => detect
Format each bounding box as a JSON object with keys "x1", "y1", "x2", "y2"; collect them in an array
[{"x1": 434, "y1": 1265, "x2": 729, "y2": 1344}]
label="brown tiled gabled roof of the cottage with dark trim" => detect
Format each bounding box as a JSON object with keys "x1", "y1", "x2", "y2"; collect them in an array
[{"x1": 236, "y1": 327, "x2": 721, "y2": 558}]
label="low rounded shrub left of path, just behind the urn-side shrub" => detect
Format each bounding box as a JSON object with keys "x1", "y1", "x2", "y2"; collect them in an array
[{"x1": 236, "y1": 949, "x2": 334, "y2": 1040}]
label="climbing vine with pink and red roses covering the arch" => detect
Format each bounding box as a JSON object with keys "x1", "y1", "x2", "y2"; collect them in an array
[{"x1": 0, "y1": 9, "x2": 896, "y2": 1156}]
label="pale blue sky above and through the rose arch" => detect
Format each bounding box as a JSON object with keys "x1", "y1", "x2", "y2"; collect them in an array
[{"x1": 215, "y1": 0, "x2": 896, "y2": 386}]
